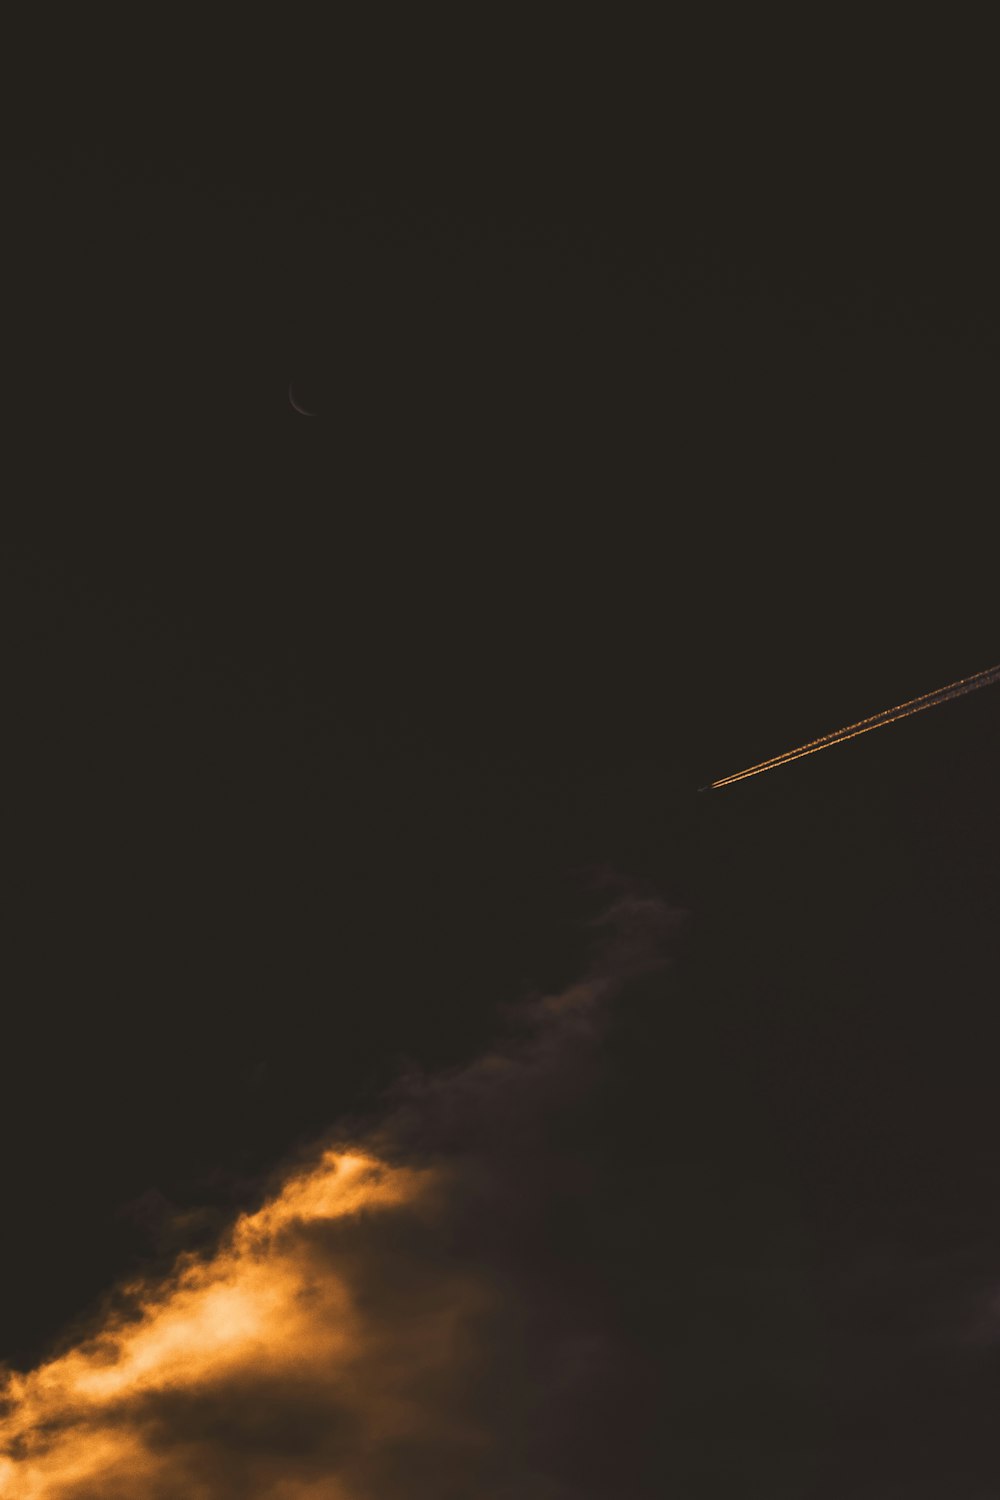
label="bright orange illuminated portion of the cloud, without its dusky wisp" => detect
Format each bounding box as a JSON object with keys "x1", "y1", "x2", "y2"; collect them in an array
[{"x1": 0, "y1": 1151, "x2": 488, "y2": 1500}]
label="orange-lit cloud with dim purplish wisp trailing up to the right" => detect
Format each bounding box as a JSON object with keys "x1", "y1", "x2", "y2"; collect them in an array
[{"x1": 0, "y1": 893, "x2": 675, "y2": 1500}]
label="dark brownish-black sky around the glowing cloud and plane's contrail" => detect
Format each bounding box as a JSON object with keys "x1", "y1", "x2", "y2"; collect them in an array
[{"x1": 0, "y1": 32, "x2": 1000, "y2": 1500}]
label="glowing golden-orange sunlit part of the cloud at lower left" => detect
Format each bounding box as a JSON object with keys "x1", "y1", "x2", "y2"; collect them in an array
[{"x1": 0, "y1": 1151, "x2": 488, "y2": 1500}]
